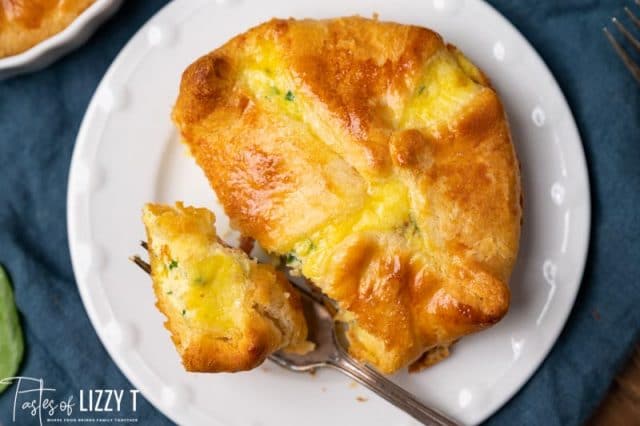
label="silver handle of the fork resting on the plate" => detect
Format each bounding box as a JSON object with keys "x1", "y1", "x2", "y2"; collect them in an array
[{"x1": 330, "y1": 353, "x2": 457, "y2": 426}]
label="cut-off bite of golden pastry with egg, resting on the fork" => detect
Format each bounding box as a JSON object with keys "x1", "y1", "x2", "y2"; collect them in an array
[{"x1": 143, "y1": 203, "x2": 312, "y2": 372}]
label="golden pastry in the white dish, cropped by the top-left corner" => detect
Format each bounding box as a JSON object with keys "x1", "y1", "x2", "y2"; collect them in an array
[{"x1": 0, "y1": 0, "x2": 95, "y2": 58}]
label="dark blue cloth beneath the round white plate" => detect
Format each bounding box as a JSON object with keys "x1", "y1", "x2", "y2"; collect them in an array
[{"x1": 0, "y1": 0, "x2": 640, "y2": 425}]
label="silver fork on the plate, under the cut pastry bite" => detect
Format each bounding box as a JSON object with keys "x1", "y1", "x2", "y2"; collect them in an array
[{"x1": 130, "y1": 241, "x2": 457, "y2": 426}]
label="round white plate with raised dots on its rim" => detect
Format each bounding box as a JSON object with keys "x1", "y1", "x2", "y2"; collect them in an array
[{"x1": 68, "y1": 0, "x2": 590, "y2": 426}]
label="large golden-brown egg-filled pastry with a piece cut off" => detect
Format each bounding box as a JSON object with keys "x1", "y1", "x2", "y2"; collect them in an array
[{"x1": 173, "y1": 17, "x2": 521, "y2": 372}]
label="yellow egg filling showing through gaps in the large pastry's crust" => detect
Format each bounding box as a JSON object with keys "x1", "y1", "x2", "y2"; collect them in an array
[{"x1": 241, "y1": 42, "x2": 482, "y2": 283}]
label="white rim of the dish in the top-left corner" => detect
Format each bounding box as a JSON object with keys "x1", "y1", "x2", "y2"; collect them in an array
[{"x1": 0, "y1": 0, "x2": 122, "y2": 80}]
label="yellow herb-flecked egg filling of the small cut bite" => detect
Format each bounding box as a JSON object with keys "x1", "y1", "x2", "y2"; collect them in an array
[{"x1": 144, "y1": 203, "x2": 250, "y2": 335}]
